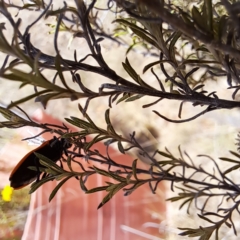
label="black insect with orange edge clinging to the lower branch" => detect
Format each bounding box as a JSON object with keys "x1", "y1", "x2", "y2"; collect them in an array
[{"x1": 9, "y1": 137, "x2": 71, "y2": 189}]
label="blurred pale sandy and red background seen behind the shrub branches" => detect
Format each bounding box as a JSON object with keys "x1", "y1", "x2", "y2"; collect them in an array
[{"x1": 0, "y1": 0, "x2": 239, "y2": 240}]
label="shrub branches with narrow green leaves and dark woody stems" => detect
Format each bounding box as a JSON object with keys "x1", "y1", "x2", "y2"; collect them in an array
[{"x1": 0, "y1": 0, "x2": 240, "y2": 239}]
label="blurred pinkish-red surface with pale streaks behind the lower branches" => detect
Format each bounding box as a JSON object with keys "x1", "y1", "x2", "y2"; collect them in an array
[{"x1": 19, "y1": 113, "x2": 166, "y2": 240}]
